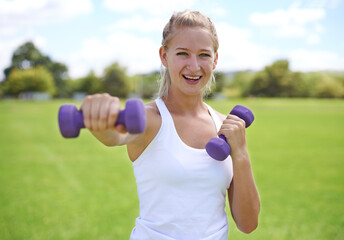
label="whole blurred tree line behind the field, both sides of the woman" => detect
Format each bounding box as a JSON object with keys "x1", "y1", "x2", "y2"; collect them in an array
[{"x1": 0, "y1": 42, "x2": 344, "y2": 98}]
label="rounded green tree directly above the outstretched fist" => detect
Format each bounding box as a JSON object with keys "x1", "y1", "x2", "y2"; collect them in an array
[{"x1": 103, "y1": 63, "x2": 130, "y2": 98}]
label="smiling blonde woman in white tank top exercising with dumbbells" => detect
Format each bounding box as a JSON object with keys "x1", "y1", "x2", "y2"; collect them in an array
[{"x1": 81, "y1": 11, "x2": 260, "y2": 240}]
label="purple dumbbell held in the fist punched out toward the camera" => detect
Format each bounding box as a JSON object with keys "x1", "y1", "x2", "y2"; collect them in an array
[{"x1": 58, "y1": 99, "x2": 146, "y2": 138}]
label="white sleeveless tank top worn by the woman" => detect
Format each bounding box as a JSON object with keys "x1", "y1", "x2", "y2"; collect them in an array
[{"x1": 130, "y1": 98, "x2": 233, "y2": 240}]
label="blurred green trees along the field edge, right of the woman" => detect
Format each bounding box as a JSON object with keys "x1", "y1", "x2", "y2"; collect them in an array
[{"x1": 228, "y1": 60, "x2": 344, "y2": 98}]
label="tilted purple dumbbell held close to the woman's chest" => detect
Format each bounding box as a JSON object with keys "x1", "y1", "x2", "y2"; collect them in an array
[{"x1": 205, "y1": 105, "x2": 254, "y2": 161}]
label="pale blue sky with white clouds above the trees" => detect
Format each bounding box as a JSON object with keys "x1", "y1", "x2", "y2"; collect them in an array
[{"x1": 0, "y1": 0, "x2": 344, "y2": 79}]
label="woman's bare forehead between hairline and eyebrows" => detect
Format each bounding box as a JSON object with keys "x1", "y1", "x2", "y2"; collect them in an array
[{"x1": 168, "y1": 27, "x2": 214, "y2": 51}]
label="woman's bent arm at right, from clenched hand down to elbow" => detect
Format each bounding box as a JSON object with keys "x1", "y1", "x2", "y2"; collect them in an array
[{"x1": 219, "y1": 115, "x2": 260, "y2": 233}]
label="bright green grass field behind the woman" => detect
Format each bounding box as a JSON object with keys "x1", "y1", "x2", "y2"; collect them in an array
[{"x1": 0, "y1": 99, "x2": 344, "y2": 240}]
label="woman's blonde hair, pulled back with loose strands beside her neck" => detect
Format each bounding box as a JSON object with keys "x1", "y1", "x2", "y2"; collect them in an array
[{"x1": 158, "y1": 10, "x2": 219, "y2": 98}]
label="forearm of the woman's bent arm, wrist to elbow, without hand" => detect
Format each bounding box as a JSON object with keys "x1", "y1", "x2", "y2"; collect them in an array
[{"x1": 229, "y1": 151, "x2": 260, "y2": 233}]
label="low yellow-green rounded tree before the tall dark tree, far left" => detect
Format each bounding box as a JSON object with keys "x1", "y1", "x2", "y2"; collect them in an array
[{"x1": 3, "y1": 66, "x2": 56, "y2": 96}]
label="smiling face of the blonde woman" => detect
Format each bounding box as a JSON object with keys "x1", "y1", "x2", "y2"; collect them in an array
[{"x1": 160, "y1": 27, "x2": 218, "y2": 95}]
